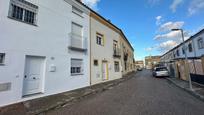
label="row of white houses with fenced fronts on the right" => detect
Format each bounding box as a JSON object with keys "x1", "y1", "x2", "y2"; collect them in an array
[{"x1": 161, "y1": 29, "x2": 204, "y2": 84}]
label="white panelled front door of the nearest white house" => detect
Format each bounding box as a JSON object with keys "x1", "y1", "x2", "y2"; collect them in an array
[{"x1": 23, "y1": 56, "x2": 45, "y2": 96}]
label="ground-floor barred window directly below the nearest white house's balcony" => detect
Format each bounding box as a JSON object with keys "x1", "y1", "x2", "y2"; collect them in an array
[{"x1": 71, "y1": 59, "x2": 83, "y2": 75}]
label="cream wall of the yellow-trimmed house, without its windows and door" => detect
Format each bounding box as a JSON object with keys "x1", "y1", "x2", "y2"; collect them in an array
[{"x1": 91, "y1": 17, "x2": 122, "y2": 85}]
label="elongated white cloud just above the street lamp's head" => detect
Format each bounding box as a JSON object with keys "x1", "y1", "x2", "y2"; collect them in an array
[{"x1": 159, "y1": 21, "x2": 184, "y2": 32}]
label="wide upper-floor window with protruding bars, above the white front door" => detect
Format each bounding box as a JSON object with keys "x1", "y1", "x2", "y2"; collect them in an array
[{"x1": 9, "y1": 0, "x2": 38, "y2": 25}]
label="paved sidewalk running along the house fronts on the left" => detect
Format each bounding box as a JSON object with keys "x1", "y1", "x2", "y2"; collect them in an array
[{"x1": 0, "y1": 72, "x2": 135, "y2": 115}]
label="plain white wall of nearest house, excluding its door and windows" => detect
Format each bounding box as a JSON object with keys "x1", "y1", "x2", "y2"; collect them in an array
[{"x1": 0, "y1": 0, "x2": 90, "y2": 106}]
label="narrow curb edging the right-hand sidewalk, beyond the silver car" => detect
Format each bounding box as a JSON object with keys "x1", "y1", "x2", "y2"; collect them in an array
[{"x1": 166, "y1": 78, "x2": 204, "y2": 102}]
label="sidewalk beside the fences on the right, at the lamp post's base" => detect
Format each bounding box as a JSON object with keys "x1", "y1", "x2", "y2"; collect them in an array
[{"x1": 167, "y1": 78, "x2": 204, "y2": 101}]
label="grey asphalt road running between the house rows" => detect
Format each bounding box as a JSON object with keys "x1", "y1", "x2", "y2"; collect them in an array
[{"x1": 46, "y1": 70, "x2": 204, "y2": 115}]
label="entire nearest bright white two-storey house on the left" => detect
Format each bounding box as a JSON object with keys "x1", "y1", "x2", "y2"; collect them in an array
[{"x1": 0, "y1": 0, "x2": 90, "y2": 106}]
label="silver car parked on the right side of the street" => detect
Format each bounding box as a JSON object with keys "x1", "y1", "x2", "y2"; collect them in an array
[{"x1": 152, "y1": 67, "x2": 169, "y2": 77}]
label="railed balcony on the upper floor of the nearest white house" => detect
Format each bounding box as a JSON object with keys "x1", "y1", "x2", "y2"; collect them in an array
[{"x1": 69, "y1": 33, "x2": 88, "y2": 52}]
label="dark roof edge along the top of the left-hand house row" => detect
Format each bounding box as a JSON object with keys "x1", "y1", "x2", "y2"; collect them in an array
[{"x1": 76, "y1": 0, "x2": 134, "y2": 51}]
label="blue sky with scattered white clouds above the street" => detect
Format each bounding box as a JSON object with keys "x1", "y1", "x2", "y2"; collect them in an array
[{"x1": 82, "y1": 0, "x2": 204, "y2": 60}]
